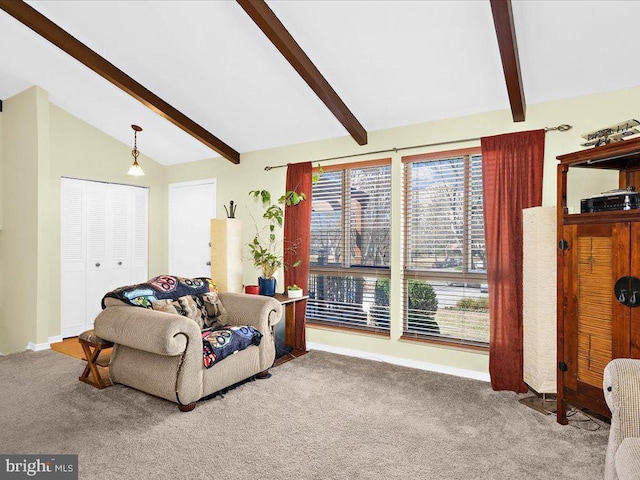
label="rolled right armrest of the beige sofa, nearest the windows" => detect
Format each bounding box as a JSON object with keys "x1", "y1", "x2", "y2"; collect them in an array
[{"x1": 219, "y1": 293, "x2": 282, "y2": 334}]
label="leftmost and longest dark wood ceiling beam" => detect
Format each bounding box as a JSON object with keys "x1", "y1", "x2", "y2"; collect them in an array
[{"x1": 0, "y1": 0, "x2": 240, "y2": 164}]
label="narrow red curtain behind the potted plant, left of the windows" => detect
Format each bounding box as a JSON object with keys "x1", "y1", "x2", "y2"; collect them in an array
[{"x1": 284, "y1": 162, "x2": 313, "y2": 350}]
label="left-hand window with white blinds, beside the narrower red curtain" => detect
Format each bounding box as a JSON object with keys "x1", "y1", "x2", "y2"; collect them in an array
[{"x1": 306, "y1": 160, "x2": 391, "y2": 332}]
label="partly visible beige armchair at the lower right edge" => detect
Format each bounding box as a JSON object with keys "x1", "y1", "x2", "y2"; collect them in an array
[{"x1": 603, "y1": 358, "x2": 640, "y2": 480}]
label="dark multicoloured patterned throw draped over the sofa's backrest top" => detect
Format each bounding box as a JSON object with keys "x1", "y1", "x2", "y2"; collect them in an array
[{"x1": 102, "y1": 275, "x2": 217, "y2": 310}]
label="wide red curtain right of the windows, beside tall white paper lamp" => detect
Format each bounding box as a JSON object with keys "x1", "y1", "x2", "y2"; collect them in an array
[{"x1": 481, "y1": 130, "x2": 544, "y2": 393}]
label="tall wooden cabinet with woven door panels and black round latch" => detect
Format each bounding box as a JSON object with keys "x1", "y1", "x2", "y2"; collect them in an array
[{"x1": 557, "y1": 139, "x2": 640, "y2": 424}]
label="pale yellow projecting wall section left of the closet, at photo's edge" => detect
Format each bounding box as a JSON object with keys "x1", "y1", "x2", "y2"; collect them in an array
[{"x1": 0, "y1": 87, "x2": 49, "y2": 353}]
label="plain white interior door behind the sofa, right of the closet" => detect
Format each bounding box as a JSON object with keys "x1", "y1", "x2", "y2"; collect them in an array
[{"x1": 169, "y1": 178, "x2": 216, "y2": 277}]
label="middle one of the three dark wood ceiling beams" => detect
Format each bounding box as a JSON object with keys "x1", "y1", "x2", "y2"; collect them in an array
[{"x1": 236, "y1": 0, "x2": 367, "y2": 145}]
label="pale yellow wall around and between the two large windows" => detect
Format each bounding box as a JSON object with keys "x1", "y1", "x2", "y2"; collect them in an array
[{"x1": 167, "y1": 87, "x2": 640, "y2": 373}]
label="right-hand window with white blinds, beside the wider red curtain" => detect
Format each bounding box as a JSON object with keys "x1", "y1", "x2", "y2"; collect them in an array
[{"x1": 402, "y1": 149, "x2": 489, "y2": 346}]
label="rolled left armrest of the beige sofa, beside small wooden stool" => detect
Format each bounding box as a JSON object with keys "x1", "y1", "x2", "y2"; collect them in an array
[{"x1": 94, "y1": 305, "x2": 202, "y2": 356}]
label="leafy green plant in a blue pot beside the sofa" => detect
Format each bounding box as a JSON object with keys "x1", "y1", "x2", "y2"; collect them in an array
[{"x1": 249, "y1": 190, "x2": 307, "y2": 296}]
